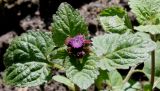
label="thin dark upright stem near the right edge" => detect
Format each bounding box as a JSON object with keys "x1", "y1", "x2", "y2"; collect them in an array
[{"x1": 150, "y1": 35, "x2": 156, "y2": 91}]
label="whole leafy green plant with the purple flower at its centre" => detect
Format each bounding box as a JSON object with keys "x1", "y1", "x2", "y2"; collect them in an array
[{"x1": 3, "y1": 0, "x2": 160, "y2": 91}]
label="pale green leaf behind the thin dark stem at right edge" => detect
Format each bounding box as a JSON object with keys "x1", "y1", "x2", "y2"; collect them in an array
[{"x1": 143, "y1": 42, "x2": 160, "y2": 89}]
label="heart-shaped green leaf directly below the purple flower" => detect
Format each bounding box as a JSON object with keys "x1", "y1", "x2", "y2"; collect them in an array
[{"x1": 65, "y1": 57, "x2": 99, "y2": 89}]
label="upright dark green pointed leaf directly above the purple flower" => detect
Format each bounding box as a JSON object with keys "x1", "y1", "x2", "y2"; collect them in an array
[{"x1": 52, "y1": 3, "x2": 88, "y2": 46}]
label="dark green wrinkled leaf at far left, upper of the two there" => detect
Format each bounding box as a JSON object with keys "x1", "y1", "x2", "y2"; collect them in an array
[{"x1": 4, "y1": 31, "x2": 55, "y2": 67}]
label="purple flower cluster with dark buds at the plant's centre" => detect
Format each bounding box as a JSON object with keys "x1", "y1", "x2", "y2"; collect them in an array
[{"x1": 66, "y1": 35, "x2": 90, "y2": 58}]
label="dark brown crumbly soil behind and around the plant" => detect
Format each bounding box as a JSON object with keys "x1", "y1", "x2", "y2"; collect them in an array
[{"x1": 0, "y1": 0, "x2": 145, "y2": 91}]
